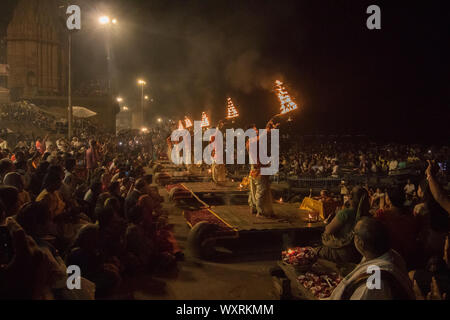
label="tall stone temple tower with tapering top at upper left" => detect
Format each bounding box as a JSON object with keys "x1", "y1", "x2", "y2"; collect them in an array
[{"x1": 6, "y1": 0, "x2": 68, "y2": 99}]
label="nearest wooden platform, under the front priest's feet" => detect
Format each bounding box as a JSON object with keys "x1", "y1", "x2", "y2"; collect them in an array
[{"x1": 210, "y1": 203, "x2": 325, "y2": 232}]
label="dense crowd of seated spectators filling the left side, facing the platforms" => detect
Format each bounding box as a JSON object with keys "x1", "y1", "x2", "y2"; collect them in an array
[{"x1": 0, "y1": 127, "x2": 183, "y2": 299}]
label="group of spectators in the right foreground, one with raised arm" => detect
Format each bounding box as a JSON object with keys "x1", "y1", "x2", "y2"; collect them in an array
[{"x1": 318, "y1": 161, "x2": 450, "y2": 299}]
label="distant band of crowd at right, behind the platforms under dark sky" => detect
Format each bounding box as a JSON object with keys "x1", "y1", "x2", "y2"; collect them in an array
[{"x1": 280, "y1": 140, "x2": 450, "y2": 178}]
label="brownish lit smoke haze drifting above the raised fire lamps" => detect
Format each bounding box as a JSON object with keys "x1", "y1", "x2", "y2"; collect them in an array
[{"x1": 70, "y1": 0, "x2": 300, "y2": 121}]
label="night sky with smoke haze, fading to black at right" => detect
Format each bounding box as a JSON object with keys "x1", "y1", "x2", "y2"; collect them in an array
[{"x1": 2, "y1": 0, "x2": 450, "y2": 140}]
